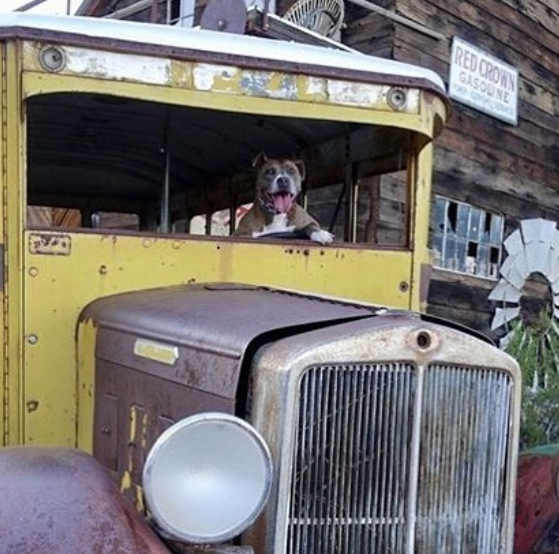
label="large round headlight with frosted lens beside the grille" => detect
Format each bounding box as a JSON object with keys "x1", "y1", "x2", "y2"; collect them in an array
[{"x1": 143, "y1": 413, "x2": 272, "y2": 543}]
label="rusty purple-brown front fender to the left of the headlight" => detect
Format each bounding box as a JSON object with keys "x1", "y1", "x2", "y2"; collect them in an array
[{"x1": 0, "y1": 447, "x2": 170, "y2": 554}]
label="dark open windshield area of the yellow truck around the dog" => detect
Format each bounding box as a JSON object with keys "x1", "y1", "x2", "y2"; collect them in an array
[{"x1": 27, "y1": 93, "x2": 410, "y2": 246}]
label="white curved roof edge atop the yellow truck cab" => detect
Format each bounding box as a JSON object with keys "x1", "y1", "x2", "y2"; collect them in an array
[{"x1": 0, "y1": 12, "x2": 445, "y2": 93}]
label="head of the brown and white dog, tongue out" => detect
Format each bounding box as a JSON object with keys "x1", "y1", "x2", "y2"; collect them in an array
[{"x1": 253, "y1": 154, "x2": 305, "y2": 214}]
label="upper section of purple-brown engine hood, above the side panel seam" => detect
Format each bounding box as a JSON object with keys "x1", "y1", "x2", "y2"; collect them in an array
[{"x1": 80, "y1": 284, "x2": 377, "y2": 398}]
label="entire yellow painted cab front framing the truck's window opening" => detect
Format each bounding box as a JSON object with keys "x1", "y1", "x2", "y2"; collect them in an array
[{"x1": 6, "y1": 34, "x2": 446, "y2": 449}]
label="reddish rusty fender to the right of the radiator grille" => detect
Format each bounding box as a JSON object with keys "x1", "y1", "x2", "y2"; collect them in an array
[{"x1": 514, "y1": 445, "x2": 559, "y2": 554}]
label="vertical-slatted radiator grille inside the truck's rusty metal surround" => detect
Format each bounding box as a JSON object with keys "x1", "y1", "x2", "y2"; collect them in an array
[{"x1": 287, "y1": 363, "x2": 512, "y2": 554}]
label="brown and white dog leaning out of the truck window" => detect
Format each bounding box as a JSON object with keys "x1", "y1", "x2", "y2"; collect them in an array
[{"x1": 235, "y1": 153, "x2": 334, "y2": 244}]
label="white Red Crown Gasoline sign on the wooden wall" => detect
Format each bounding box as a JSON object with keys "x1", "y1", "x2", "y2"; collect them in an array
[{"x1": 449, "y1": 37, "x2": 518, "y2": 125}]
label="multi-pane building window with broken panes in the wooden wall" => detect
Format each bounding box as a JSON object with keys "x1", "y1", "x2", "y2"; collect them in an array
[{"x1": 431, "y1": 196, "x2": 504, "y2": 279}]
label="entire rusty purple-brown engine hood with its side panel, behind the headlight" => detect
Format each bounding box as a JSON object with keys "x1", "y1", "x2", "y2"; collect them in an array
[{"x1": 81, "y1": 284, "x2": 376, "y2": 505}]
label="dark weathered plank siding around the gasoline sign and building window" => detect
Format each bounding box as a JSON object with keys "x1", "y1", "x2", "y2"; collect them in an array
[{"x1": 343, "y1": 0, "x2": 559, "y2": 336}]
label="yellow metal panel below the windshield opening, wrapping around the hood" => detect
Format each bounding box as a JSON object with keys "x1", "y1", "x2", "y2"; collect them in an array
[{"x1": 25, "y1": 231, "x2": 411, "y2": 446}]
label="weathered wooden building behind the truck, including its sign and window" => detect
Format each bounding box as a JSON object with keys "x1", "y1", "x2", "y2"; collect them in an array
[{"x1": 73, "y1": 0, "x2": 559, "y2": 337}]
